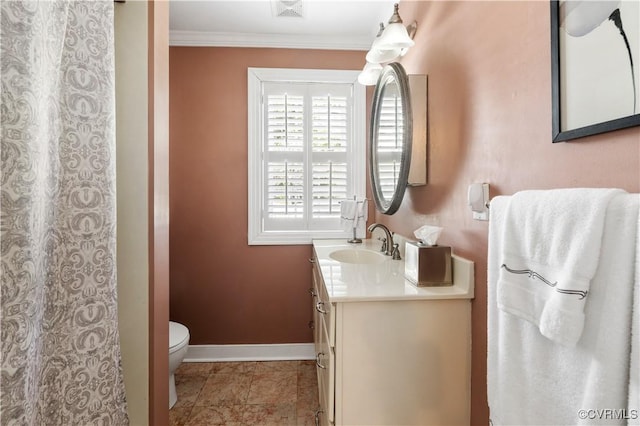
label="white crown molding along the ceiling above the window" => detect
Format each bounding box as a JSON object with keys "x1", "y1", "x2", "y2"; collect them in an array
[{"x1": 169, "y1": 31, "x2": 371, "y2": 51}]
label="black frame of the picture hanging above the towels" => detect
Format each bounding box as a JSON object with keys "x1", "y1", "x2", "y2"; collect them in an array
[{"x1": 550, "y1": 0, "x2": 640, "y2": 143}]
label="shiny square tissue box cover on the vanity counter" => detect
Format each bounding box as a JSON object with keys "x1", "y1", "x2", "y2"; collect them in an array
[{"x1": 404, "y1": 241, "x2": 453, "y2": 287}]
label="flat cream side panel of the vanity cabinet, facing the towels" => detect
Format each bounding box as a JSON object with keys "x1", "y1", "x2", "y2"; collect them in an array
[{"x1": 335, "y1": 299, "x2": 471, "y2": 426}]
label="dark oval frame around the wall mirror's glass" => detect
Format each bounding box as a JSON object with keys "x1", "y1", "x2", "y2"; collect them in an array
[{"x1": 369, "y1": 62, "x2": 413, "y2": 215}]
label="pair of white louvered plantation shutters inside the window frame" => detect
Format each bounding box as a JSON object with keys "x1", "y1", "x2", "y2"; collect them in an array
[{"x1": 263, "y1": 83, "x2": 355, "y2": 231}]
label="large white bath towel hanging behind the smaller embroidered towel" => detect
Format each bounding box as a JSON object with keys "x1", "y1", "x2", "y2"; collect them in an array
[{"x1": 487, "y1": 194, "x2": 640, "y2": 426}]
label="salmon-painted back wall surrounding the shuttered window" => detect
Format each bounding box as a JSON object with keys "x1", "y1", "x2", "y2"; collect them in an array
[{"x1": 169, "y1": 47, "x2": 364, "y2": 345}]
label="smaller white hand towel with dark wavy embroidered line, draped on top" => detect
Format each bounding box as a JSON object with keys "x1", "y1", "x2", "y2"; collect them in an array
[{"x1": 498, "y1": 189, "x2": 624, "y2": 346}]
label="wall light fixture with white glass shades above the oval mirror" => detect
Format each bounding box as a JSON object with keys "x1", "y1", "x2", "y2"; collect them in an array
[{"x1": 358, "y1": 3, "x2": 418, "y2": 86}]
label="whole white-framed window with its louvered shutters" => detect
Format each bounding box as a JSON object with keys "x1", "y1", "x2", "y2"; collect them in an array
[{"x1": 249, "y1": 69, "x2": 365, "y2": 244}]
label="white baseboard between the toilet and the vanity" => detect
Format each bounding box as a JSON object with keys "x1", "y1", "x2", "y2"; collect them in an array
[{"x1": 184, "y1": 343, "x2": 316, "y2": 362}]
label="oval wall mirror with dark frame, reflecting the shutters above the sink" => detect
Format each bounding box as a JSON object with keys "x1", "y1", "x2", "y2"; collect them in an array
[{"x1": 369, "y1": 62, "x2": 413, "y2": 214}]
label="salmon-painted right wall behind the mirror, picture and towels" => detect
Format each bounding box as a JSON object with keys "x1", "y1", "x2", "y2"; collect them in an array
[{"x1": 375, "y1": 1, "x2": 640, "y2": 425}]
